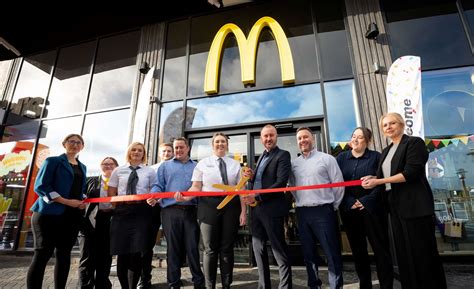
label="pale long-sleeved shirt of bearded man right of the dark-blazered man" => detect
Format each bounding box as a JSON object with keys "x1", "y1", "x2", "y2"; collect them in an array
[{"x1": 290, "y1": 149, "x2": 344, "y2": 210}]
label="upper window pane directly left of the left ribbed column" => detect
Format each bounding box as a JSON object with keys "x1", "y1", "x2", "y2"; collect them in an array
[{"x1": 87, "y1": 31, "x2": 140, "y2": 110}]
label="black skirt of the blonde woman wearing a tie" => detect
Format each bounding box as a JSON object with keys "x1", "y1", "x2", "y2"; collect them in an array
[{"x1": 110, "y1": 202, "x2": 152, "y2": 255}]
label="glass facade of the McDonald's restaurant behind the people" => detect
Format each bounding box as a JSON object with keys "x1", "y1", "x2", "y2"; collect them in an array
[{"x1": 0, "y1": 0, "x2": 474, "y2": 254}]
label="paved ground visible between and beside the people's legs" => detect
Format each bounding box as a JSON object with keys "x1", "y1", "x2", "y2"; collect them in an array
[{"x1": 0, "y1": 253, "x2": 474, "y2": 289}]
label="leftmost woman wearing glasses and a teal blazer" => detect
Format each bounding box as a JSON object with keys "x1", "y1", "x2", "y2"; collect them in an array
[{"x1": 26, "y1": 134, "x2": 86, "y2": 288}]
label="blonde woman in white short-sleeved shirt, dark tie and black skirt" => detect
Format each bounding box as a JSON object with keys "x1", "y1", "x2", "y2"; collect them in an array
[{"x1": 108, "y1": 142, "x2": 156, "y2": 289}]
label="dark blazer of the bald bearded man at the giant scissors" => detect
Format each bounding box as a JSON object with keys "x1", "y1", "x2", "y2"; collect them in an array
[{"x1": 249, "y1": 147, "x2": 291, "y2": 217}]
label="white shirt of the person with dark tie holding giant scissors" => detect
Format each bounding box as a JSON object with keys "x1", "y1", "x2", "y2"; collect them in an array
[{"x1": 192, "y1": 155, "x2": 240, "y2": 192}]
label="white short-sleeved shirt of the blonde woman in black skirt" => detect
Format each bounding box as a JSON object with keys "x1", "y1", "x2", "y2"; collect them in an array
[{"x1": 109, "y1": 164, "x2": 156, "y2": 196}]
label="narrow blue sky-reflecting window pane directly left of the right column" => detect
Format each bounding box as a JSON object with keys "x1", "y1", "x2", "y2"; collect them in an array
[{"x1": 324, "y1": 79, "x2": 359, "y2": 142}]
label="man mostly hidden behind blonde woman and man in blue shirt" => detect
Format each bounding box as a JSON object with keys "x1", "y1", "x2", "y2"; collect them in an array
[{"x1": 138, "y1": 143, "x2": 174, "y2": 288}]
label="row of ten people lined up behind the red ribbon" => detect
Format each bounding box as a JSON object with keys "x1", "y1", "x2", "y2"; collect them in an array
[{"x1": 27, "y1": 113, "x2": 446, "y2": 289}]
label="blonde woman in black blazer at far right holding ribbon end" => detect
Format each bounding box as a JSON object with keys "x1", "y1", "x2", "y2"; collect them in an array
[{"x1": 362, "y1": 112, "x2": 446, "y2": 289}]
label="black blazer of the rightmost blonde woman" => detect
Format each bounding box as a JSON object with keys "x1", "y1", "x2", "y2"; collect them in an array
[{"x1": 377, "y1": 135, "x2": 434, "y2": 218}]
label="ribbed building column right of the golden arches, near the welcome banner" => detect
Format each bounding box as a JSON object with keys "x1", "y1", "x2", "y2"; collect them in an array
[{"x1": 345, "y1": 0, "x2": 392, "y2": 151}]
